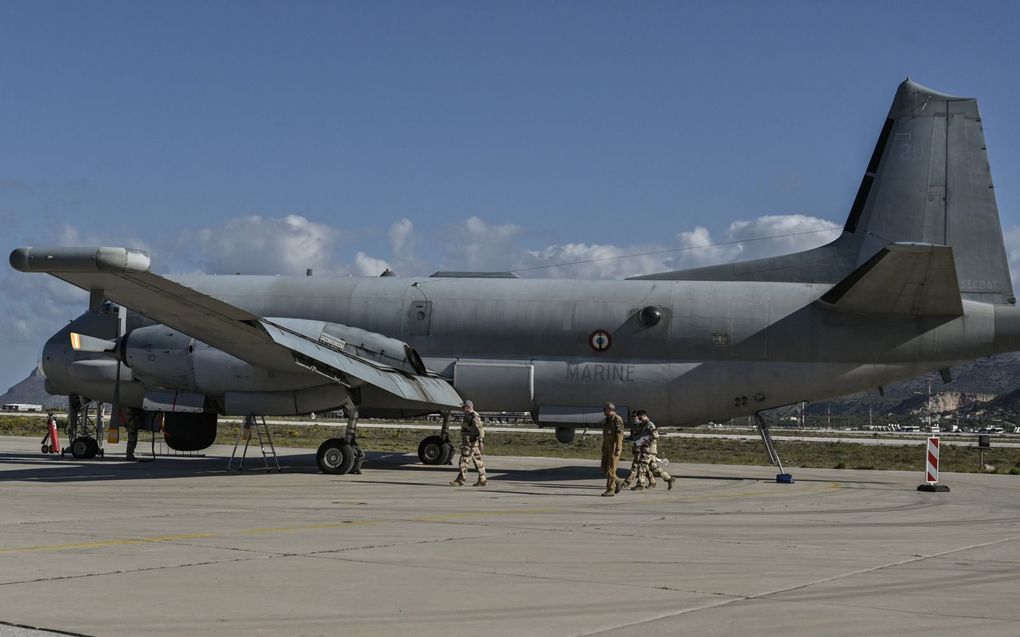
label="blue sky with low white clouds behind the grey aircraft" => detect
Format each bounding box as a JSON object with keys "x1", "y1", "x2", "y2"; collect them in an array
[{"x1": 0, "y1": 0, "x2": 1020, "y2": 389}]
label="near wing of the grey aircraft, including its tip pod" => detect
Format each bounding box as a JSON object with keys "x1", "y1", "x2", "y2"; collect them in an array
[{"x1": 10, "y1": 248, "x2": 462, "y2": 408}]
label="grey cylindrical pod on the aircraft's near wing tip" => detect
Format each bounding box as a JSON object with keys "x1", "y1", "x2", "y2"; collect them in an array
[{"x1": 9, "y1": 247, "x2": 151, "y2": 274}]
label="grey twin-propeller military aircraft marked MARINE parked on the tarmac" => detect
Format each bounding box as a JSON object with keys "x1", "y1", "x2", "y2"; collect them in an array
[{"x1": 10, "y1": 79, "x2": 1020, "y2": 474}]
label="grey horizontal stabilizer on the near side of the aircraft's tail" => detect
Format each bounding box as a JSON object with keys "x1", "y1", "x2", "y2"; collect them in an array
[{"x1": 821, "y1": 244, "x2": 963, "y2": 316}]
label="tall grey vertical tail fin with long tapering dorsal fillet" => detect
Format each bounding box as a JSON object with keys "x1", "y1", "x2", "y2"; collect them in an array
[{"x1": 636, "y1": 79, "x2": 1015, "y2": 303}]
